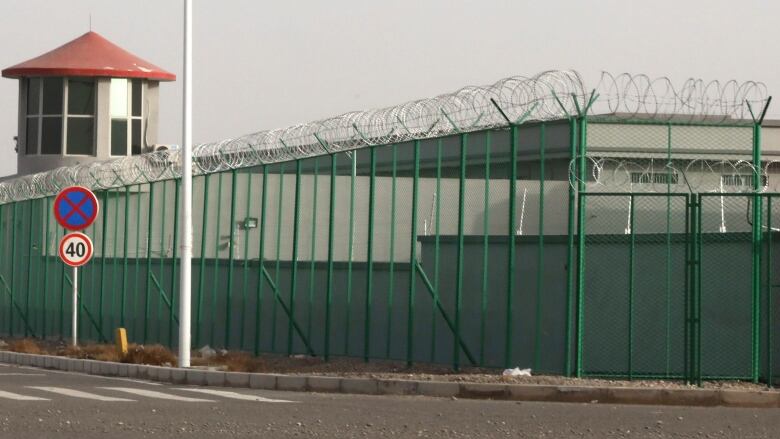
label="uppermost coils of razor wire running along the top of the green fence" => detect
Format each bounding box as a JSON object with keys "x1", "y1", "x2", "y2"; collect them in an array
[{"x1": 0, "y1": 70, "x2": 766, "y2": 204}]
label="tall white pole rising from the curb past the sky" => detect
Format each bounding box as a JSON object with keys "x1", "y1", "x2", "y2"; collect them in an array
[{"x1": 179, "y1": 0, "x2": 192, "y2": 367}]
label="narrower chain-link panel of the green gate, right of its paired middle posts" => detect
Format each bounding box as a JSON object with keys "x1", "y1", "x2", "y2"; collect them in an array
[{"x1": 696, "y1": 194, "x2": 760, "y2": 379}]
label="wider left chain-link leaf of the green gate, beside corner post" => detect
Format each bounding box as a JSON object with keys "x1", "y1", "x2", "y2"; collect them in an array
[{"x1": 580, "y1": 194, "x2": 688, "y2": 378}]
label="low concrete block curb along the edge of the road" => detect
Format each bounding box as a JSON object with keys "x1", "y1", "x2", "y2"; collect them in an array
[{"x1": 0, "y1": 351, "x2": 780, "y2": 408}]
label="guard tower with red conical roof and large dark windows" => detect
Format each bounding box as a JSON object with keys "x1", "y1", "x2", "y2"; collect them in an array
[{"x1": 2, "y1": 32, "x2": 176, "y2": 175}]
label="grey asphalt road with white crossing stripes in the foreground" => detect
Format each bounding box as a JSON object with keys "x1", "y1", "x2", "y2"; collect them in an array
[{"x1": 0, "y1": 365, "x2": 780, "y2": 439}]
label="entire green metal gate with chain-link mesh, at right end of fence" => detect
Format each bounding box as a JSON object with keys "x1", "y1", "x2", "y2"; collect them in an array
[{"x1": 578, "y1": 193, "x2": 780, "y2": 385}]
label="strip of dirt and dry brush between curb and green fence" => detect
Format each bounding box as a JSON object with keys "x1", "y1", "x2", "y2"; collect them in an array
[{"x1": 0, "y1": 339, "x2": 767, "y2": 390}]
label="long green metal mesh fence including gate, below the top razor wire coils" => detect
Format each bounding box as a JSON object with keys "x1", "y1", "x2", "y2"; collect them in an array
[{"x1": 0, "y1": 109, "x2": 780, "y2": 381}]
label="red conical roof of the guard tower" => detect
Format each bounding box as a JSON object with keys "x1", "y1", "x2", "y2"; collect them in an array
[{"x1": 2, "y1": 32, "x2": 176, "y2": 81}]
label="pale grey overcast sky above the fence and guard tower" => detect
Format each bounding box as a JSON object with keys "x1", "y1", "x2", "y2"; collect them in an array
[{"x1": 0, "y1": 0, "x2": 780, "y2": 176}]
